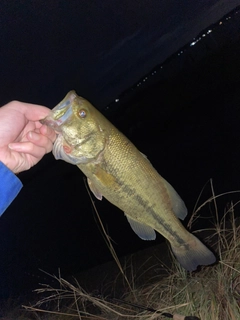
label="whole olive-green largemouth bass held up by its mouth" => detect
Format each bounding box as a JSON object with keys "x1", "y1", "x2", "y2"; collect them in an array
[{"x1": 41, "y1": 90, "x2": 216, "y2": 271}]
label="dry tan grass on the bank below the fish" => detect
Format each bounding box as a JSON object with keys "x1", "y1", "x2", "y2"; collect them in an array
[{"x1": 2, "y1": 179, "x2": 240, "y2": 320}]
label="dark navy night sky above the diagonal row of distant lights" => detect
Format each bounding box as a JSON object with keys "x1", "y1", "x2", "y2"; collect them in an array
[{"x1": 0, "y1": 0, "x2": 240, "y2": 107}]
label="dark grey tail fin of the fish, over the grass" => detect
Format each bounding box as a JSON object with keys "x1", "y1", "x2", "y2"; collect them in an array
[{"x1": 172, "y1": 235, "x2": 216, "y2": 271}]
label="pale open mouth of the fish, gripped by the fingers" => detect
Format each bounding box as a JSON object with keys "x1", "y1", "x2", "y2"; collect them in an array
[{"x1": 40, "y1": 90, "x2": 77, "y2": 133}]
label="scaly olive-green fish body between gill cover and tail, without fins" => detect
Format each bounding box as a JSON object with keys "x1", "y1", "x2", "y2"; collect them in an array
[{"x1": 78, "y1": 129, "x2": 190, "y2": 246}]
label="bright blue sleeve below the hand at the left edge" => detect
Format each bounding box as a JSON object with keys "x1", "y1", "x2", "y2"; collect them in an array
[{"x1": 0, "y1": 161, "x2": 22, "y2": 216}]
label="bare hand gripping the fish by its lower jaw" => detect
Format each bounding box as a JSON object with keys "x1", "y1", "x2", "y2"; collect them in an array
[{"x1": 0, "y1": 101, "x2": 56, "y2": 173}]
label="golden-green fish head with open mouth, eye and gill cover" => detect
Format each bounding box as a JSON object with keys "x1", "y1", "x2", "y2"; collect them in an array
[{"x1": 41, "y1": 91, "x2": 106, "y2": 164}]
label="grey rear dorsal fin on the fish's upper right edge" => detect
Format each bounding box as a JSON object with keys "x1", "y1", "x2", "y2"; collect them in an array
[{"x1": 162, "y1": 178, "x2": 187, "y2": 220}]
